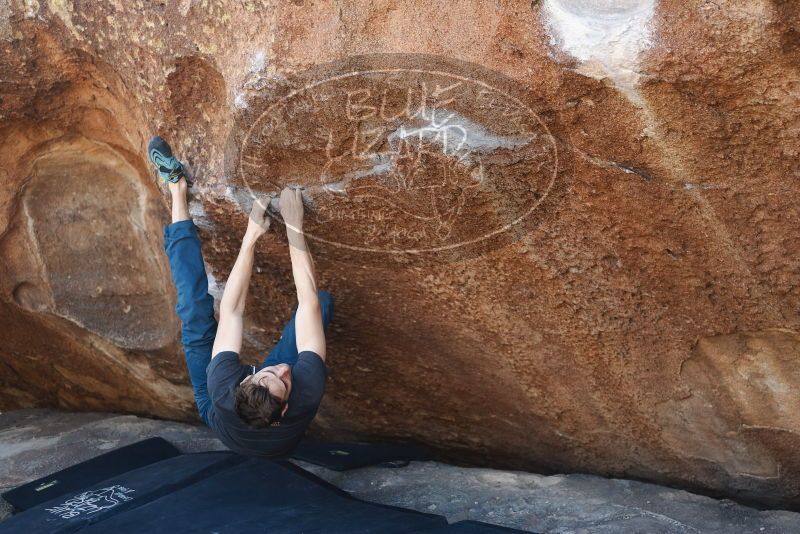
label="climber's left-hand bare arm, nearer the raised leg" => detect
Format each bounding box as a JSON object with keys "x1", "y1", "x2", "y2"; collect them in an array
[{"x1": 211, "y1": 201, "x2": 270, "y2": 358}]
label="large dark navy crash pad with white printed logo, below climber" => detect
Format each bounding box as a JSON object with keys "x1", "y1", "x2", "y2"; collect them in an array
[{"x1": 0, "y1": 440, "x2": 536, "y2": 534}]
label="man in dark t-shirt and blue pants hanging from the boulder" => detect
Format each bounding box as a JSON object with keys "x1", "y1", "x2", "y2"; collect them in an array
[{"x1": 148, "y1": 137, "x2": 333, "y2": 458}]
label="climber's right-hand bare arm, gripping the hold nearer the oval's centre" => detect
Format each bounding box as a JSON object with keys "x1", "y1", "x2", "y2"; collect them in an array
[{"x1": 280, "y1": 187, "x2": 325, "y2": 360}]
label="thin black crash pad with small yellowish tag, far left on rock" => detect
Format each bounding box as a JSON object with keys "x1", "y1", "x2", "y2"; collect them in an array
[{"x1": 3, "y1": 438, "x2": 180, "y2": 511}]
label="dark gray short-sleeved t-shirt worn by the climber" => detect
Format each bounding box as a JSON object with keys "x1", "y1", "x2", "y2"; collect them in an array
[{"x1": 206, "y1": 351, "x2": 328, "y2": 458}]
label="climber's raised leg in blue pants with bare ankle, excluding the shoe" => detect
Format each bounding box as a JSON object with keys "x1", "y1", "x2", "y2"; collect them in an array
[{"x1": 159, "y1": 163, "x2": 217, "y2": 424}]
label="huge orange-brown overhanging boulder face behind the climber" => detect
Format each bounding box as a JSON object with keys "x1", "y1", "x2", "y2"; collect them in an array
[{"x1": 0, "y1": 0, "x2": 800, "y2": 504}]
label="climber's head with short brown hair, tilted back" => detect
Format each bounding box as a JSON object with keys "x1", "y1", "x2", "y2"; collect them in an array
[{"x1": 235, "y1": 363, "x2": 292, "y2": 428}]
